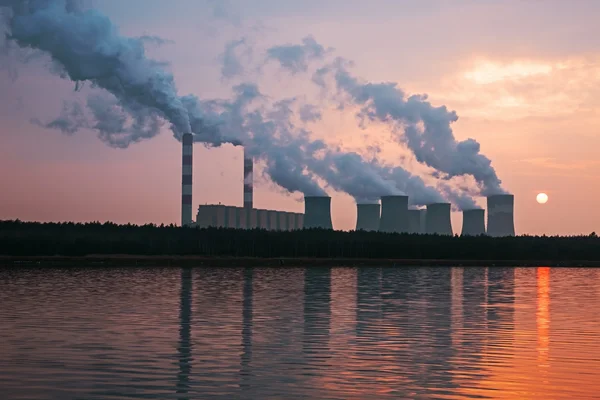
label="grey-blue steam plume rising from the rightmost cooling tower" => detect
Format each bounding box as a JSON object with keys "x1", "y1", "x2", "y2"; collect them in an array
[{"x1": 313, "y1": 59, "x2": 505, "y2": 195}]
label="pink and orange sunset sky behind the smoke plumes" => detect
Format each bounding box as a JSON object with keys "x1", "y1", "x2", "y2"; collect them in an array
[{"x1": 0, "y1": 0, "x2": 600, "y2": 235}]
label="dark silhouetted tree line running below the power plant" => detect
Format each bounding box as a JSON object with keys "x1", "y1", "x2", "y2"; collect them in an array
[{"x1": 0, "y1": 220, "x2": 600, "y2": 261}]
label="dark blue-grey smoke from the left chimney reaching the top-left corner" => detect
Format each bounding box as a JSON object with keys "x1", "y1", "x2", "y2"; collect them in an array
[{"x1": 0, "y1": 0, "x2": 235, "y2": 147}]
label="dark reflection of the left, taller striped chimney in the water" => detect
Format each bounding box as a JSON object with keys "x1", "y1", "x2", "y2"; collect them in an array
[{"x1": 177, "y1": 268, "x2": 192, "y2": 400}]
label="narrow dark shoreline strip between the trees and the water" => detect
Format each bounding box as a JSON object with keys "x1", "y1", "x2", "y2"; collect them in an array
[{"x1": 0, "y1": 254, "x2": 600, "y2": 268}]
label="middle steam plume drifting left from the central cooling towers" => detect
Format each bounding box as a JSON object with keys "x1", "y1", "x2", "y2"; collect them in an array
[{"x1": 207, "y1": 84, "x2": 408, "y2": 201}]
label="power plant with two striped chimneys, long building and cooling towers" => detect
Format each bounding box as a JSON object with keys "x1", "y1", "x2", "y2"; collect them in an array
[{"x1": 181, "y1": 139, "x2": 515, "y2": 237}]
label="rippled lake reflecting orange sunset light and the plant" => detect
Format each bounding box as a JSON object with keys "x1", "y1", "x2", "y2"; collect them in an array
[{"x1": 0, "y1": 267, "x2": 600, "y2": 400}]
